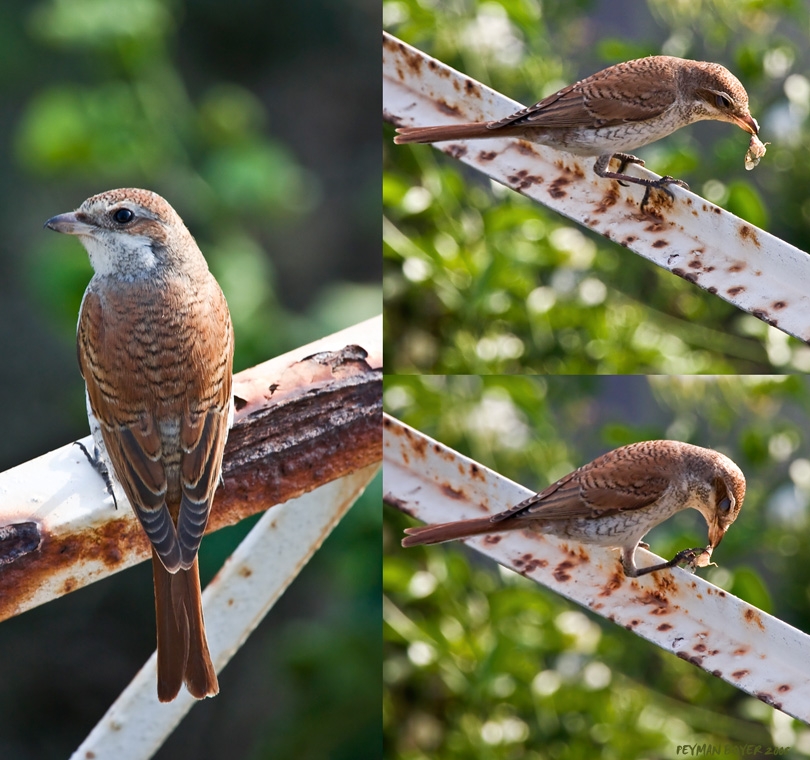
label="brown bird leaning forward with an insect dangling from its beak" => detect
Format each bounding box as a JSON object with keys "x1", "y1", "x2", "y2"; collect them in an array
[{"x1": 394, "y1": 55, "x2": 759, "y2": 205}]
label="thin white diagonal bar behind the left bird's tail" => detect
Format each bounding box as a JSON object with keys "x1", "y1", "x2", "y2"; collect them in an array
[{"x1": 72, "y1": 465, "x2": 379, "y2": 760}]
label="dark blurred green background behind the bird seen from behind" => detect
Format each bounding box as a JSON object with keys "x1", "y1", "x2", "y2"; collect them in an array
[{"x1": 0, "y1": 0, "x2": 381, "y2": 760}]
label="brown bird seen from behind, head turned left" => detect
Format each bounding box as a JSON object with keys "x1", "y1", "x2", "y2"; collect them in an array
[{"x1": 45, "y1": 188, "x2": 234, "y2": 702}]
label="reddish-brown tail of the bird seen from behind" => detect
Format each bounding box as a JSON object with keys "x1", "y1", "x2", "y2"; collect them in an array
[{"x1": 152, "y1": 550, "x2": 219, "y2": 702}]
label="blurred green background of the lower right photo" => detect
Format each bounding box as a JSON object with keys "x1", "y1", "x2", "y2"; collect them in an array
[{"x1": 383, "y1": 375, "x2": 810, "y2": 760}]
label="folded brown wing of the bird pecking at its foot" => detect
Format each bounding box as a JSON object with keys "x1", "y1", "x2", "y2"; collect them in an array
[{"x1": 493, "y1": 457, "x2": 670, "y2": 522}]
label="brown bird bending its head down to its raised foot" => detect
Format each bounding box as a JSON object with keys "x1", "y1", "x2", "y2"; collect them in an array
[{"x1": 402, "y1": 441, "x2": 745, "y2": 578}]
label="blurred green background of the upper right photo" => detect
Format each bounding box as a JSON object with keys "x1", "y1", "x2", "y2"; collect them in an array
[{"x1": 383, "y1": 0, "x2": 810, "y2": 374}]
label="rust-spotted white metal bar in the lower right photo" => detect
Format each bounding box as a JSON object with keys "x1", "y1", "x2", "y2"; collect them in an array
[{"x1": 383, "y1": 415, "x2": 810, "y2": 723}]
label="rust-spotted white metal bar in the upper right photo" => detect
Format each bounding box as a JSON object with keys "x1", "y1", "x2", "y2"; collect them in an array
[{"x1": 383, "y1": 33, "x2": 810, "y2": 341}]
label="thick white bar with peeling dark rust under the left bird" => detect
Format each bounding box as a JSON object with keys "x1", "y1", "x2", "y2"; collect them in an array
[{"x1": 0, "y1": 318, "x2": 382, "y2": 620}]
